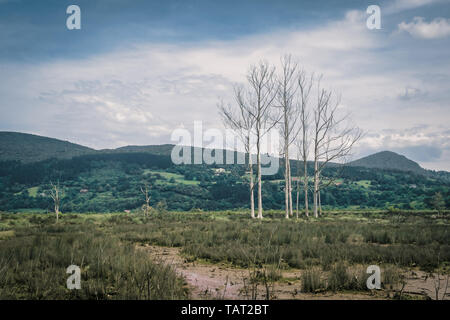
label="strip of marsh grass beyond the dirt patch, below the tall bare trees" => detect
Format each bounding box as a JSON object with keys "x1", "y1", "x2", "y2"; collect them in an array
[{"x1": 103, "y1": 211, "x2": 450, "y2": 270}]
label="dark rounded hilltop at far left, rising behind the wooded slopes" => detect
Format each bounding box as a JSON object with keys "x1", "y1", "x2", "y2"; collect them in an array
[{"x1": 0, "y1": 131, "x2": 95, "y2": 163}]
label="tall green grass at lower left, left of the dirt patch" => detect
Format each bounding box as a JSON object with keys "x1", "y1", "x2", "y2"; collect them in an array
[{"x1": 0, "y1": 214, "x2": 188, "y2": 300}]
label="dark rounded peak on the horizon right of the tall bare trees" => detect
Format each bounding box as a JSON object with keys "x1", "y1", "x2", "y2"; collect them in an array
[{"x1": 348, "y1": 151, "x2": 427, "y2": 174}]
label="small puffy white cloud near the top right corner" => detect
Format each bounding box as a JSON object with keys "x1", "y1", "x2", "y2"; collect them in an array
[{"x1": 398, "y1": 17, "x2": 450, "y2": 39}]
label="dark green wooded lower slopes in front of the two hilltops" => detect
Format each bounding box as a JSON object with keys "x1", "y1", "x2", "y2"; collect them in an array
[{"x1": 0, "y1": 153, "x2": 450, "y2": 212}]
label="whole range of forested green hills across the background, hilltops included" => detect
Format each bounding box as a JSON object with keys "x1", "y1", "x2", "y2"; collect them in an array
[{"x1": 0, "y1": 132, "x2": 450, "y2": 212}]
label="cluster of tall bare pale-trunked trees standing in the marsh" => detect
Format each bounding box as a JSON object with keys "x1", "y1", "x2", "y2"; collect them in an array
[{"x1": 219, "y1": 55, "x2": 361, "y2": 219}]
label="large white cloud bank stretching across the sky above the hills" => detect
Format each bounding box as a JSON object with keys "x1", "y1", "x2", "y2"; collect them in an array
[{"x1": 0, "y1": 11, "x2": 450, "y2": 169}]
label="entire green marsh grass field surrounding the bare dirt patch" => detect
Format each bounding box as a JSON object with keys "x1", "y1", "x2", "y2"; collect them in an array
[{"x1": 0, "y1": 210, "x2": 450, "y2": 299}]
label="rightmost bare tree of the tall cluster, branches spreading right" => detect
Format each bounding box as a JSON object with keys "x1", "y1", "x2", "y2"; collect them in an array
[{"x1": 313, "y1": 78, "x2": 362, "y2": 218}]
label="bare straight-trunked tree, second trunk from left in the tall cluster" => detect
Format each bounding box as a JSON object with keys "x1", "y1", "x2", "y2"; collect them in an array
[{"x1": 246, "y1": 61, "x2": 277, "y2": 219}]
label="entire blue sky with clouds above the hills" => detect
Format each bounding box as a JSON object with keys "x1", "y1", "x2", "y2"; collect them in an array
[{"x1": 0, "y1": 0, "x2": 450, "y2": 171}]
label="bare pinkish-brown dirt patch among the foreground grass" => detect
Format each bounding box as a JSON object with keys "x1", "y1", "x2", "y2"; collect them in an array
[{"x1": 139, "y1": 245, "x2": 449, "y2": 300}]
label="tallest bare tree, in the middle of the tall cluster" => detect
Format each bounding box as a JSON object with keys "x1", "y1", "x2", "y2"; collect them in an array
[{"x1": 276, "y1": 55, "x2": 300, "y2": 219}]
